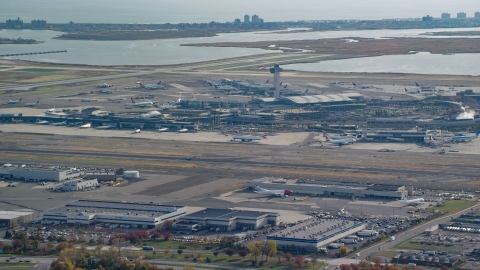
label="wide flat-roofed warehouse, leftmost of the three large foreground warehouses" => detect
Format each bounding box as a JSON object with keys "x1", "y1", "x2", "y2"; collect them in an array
[{"x1": 43, "y1": 200, "x2": 186, "y2": 229}]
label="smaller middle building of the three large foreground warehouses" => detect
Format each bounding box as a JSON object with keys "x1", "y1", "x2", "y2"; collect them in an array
[{"x1": 180, "y1": 208, "x2": 280, "y2": 231}]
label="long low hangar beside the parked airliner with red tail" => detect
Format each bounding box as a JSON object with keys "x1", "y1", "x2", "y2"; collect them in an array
[{"x1": 247, "y1": 177, "x2": 412, "y2": 200}]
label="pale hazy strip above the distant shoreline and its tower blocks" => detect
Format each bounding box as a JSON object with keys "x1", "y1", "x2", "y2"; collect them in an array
[{"x1": 0, "y1": 0, "x2": 480, "y2": 23}]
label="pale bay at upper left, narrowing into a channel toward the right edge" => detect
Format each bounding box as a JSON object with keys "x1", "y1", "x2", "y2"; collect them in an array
[{"x1": 0, "y1": 28, "x2": 479, "y2": 65}]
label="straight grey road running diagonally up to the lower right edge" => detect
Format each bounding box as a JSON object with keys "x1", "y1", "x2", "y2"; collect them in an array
[{"x1": 352, "y1": 204, "x2": 480, "y2": 260}]
